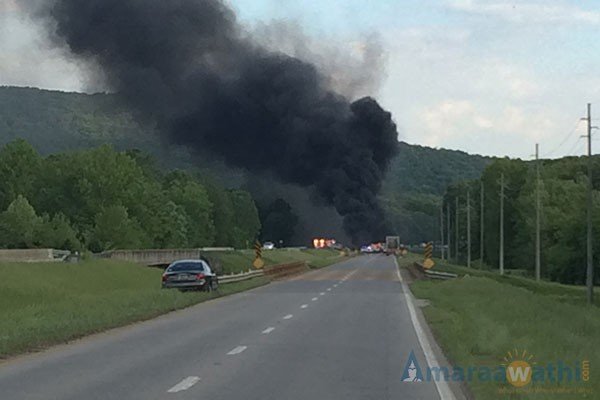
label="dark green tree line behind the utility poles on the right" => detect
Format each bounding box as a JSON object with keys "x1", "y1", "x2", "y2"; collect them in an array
[{"x1": 436, "y1": 157, "x2": 600, "y2": 284}]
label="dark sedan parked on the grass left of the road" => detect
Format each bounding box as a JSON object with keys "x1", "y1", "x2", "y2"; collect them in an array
[{"x1": 162, "y1": 260, "x2": 219, "y2": 292}]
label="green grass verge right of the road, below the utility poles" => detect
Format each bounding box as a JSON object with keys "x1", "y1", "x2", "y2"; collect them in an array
[{"x1": 400, "y1": 256, "x2": 600, "y2": 399}]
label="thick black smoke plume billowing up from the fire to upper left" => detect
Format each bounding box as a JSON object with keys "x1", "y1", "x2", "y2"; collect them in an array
[{"x1": 30, "y1": 0, "x2": 397, "y2": 243}]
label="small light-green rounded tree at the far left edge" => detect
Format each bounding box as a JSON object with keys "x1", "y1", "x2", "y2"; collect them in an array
[{"x1": 0, "y1": 195, "x2": 42, "y2": 248}]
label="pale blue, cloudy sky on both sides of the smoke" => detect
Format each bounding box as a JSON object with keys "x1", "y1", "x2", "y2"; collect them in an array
[{"x1": 0, "y1": 0, "x2": 600, "y2": 159}]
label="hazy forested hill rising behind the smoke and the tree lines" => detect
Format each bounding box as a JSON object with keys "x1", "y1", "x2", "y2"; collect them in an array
[{"x1": 0, "y1": 87, "x2": 490, "y2": 242}]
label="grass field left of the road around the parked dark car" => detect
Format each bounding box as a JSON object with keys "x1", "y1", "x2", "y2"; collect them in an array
[{"x1": 0, "y1": 260, "x2": 268, "y2": 358}]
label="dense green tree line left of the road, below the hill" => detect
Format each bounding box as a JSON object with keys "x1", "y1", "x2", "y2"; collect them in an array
[{"x1": 0, "y1": 139, "x2": 261, "y2": 252}]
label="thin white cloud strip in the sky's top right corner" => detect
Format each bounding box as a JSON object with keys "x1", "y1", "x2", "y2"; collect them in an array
[{"x1": 448, "y1": 0, "x2": 600, "y2": 25}]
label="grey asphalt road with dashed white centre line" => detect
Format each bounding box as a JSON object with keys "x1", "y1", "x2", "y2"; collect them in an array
[{"x1": 0, "y1": 255, "x2": 448, "y2": 400}]
